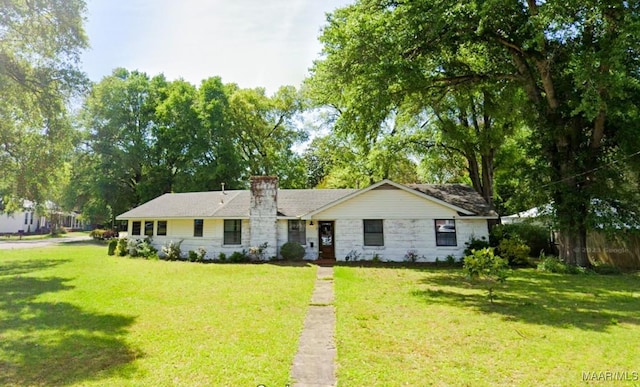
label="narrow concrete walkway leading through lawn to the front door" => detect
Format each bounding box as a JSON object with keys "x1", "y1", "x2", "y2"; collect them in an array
[{"x1": 291, "y1": 267, "x2": 337, "y2": 387}]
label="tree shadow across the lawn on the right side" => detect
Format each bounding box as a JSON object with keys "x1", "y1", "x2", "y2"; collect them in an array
[{"x1": 413, "y1": 269, "x2": 640, "y2": 331}]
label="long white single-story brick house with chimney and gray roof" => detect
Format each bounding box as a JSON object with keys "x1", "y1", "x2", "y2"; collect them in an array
[{"x1": 117, "y1": 176, "x2": 498, "y2": 261}]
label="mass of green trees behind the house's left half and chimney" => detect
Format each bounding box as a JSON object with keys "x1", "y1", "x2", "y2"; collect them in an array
[{"x1": 66, "y1": 68, "x2": 306, "y2": 224}]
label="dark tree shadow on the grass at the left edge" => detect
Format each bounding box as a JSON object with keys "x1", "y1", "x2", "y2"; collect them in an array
[{"x1": 0, "y1": 260, "x2": 141, "y2": 385}]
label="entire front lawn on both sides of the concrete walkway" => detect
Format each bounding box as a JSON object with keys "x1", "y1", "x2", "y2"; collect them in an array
[{"x1": 0, "y1": 244, "x2": 640, "y2": 386}]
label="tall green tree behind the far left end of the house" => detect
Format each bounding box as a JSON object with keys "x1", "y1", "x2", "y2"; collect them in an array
[{"x1": 79, "y1": 69, "x2": 156, "y2": 223}]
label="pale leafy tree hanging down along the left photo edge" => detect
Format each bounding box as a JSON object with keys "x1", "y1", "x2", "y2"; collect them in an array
[{"x1": 0, "y1": 0, "x2": 87, "y2": 209}]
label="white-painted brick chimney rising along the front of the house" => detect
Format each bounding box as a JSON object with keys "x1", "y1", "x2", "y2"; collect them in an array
[{"x1": 249, "y1": 176, "x2": 278, "y2": 259}]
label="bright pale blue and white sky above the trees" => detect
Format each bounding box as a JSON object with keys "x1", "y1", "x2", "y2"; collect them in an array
[{"x1": 82, "y1": 0, "x2": 353, "y2": 94}]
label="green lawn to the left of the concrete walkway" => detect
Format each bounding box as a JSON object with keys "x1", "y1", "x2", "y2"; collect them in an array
[{"x1": 0, "y1": 245, "x2": 315, "y2": 386}]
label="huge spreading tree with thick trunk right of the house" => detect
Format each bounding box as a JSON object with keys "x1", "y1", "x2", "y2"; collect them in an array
[{"x1": 314, "y1": 0, "x2": 640, "y2": 266}]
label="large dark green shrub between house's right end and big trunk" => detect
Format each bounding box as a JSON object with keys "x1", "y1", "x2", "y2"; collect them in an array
[{"x1": 489, "y1": 223, "x2": 557, "y2": 257}]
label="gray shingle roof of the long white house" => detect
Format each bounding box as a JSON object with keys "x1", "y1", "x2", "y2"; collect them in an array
[{"x1": 117, "y1": 184, "x2": 497, "y2": 219}]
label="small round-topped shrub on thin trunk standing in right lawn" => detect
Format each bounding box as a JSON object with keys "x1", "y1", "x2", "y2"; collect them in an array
[{"x1": 463, "y1": 247, "x2": 509, "y2": 303}]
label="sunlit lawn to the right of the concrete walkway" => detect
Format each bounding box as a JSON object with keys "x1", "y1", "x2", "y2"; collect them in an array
[{"x1": 335, "y1": 267, "x2": 640, "y2": 386}]
